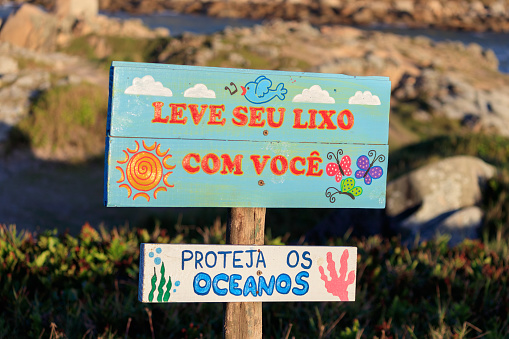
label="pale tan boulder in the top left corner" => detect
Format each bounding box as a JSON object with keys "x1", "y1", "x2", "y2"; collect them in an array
[{"x1": 0, "y1": 4, "x2": 58, "y2": 51}]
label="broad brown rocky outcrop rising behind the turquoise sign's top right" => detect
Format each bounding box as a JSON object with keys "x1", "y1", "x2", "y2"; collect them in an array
[{"x1": 153, "y1": 19, "x2": 509, "y2": 136}]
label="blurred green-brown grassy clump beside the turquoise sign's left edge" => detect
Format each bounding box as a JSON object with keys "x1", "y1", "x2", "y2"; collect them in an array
[{"x1": 12, "y1": 84, "x2": 108, "y2": 160}]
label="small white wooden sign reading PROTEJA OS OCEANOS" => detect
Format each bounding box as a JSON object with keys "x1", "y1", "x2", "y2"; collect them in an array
[{"x1": 138, "y1": 244, "x2": 357, "y2": 302}]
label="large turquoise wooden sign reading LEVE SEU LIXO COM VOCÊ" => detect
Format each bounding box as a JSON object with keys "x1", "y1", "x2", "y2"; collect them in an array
[{"x1": 105, "y1": 62, "x2": 390, "y2": 208}]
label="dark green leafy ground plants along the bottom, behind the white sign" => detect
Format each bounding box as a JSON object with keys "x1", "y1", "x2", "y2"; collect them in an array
[{"x1": 0, "y1": 224, "x2": 509, "y2": 338}]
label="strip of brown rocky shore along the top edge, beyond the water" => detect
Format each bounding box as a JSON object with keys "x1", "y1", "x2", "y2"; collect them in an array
[{"x1": 8, "y1": 0, "x2": 509, "y2": 32}]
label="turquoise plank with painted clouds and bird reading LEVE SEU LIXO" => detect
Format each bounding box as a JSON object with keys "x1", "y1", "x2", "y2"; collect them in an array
[{"x1": 109, "y1": 63, "x2": 390, "y2": 144}]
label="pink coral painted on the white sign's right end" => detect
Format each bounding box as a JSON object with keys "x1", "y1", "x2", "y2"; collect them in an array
[{"x1": 318, "y1": 250, "x2": 355, "y2": 301}]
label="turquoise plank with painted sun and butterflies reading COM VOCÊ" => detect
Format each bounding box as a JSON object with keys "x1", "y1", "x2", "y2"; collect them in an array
[{"x1": 105, "y1": 137, "x2": 388, "y2": 208}]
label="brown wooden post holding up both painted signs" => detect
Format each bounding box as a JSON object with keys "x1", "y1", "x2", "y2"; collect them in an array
[{"x1": 224, "y1": 208, "x2": 266, "y2": 339}]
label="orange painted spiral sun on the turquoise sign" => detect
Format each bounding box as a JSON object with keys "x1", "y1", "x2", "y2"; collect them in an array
[{"x1": 115, "y1": 140, "x2": 176, "y2": 201}]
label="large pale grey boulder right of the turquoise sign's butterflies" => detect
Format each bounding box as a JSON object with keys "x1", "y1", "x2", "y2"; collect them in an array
[{"x1": 386, "y1": 156, "x2": 495, "y2": 243}]
